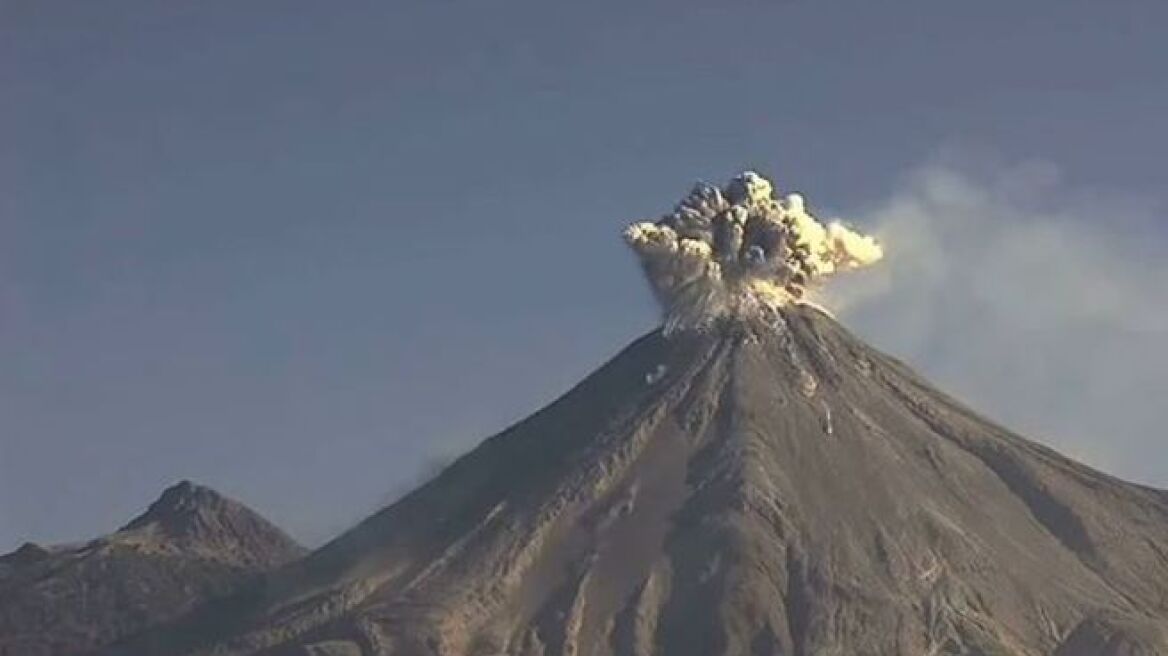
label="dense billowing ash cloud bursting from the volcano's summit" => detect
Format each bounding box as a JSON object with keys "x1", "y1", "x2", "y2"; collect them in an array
[{"x1": 625, "y1": 172, "x2": 883, "y2": 333}]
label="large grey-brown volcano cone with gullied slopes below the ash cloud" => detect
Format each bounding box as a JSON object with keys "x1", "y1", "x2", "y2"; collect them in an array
[{"x1": 109, "y1": 305, "x2": 1168, "y2": 656}]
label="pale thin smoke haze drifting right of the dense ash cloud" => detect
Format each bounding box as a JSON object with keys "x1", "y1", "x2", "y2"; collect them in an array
[{"x1": 826, "y1": 156, "x2": 1168, "y2": 486}]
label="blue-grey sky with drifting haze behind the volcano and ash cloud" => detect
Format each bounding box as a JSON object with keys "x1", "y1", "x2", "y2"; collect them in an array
[{"x1": 0, "y1": 0, "x2": 1168, "y2": 551}]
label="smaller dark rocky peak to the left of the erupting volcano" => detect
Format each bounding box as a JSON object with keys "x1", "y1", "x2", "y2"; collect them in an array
[{"x1": 0, "y1": 473, "x2": 301, "y2": 656}]
